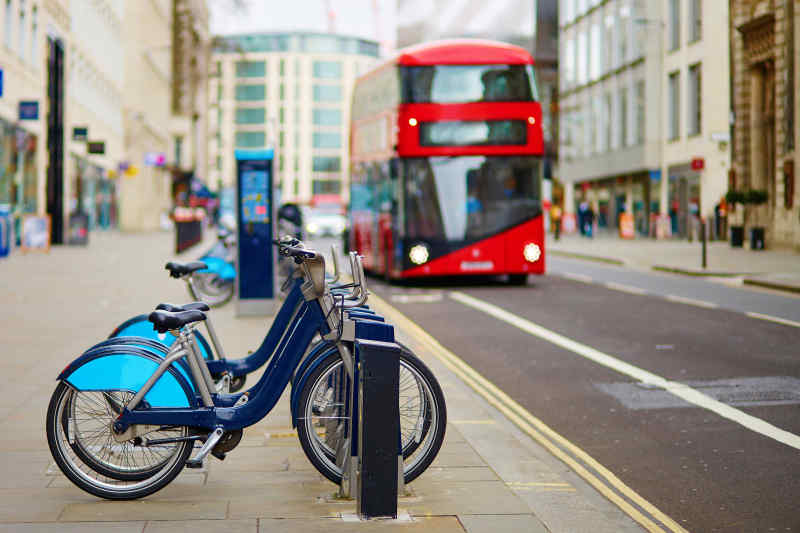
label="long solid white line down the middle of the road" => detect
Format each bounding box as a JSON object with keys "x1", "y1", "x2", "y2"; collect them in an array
[{"x1": 450, "y1": 292, "x2": 800, "y2": 450}]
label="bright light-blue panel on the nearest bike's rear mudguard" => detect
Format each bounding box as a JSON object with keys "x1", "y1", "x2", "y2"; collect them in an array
[{"x1": 66, "y1": 354, "x2": 191, "y2": 407}]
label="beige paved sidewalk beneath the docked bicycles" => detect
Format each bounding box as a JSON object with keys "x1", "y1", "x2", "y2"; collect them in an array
[{"x1": 0, "y1": 233, "x2": 641, "y2": 533}]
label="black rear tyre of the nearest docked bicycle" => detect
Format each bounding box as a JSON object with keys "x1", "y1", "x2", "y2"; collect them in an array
[{"x1": 45, "y1": 382, "x2": 193, "y2": 500}]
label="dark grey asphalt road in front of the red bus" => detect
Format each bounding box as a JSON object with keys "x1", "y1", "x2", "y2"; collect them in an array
[{"x1": 326, "y1": 255, "x2": 800, "y2": 532}]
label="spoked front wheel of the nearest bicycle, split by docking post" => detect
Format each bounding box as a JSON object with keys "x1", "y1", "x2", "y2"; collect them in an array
[{"x1": 297, "y1": 346, "x2": 447, "y2": 484}]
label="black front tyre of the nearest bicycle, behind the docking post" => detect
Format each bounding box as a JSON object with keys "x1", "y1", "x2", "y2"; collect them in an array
[{"x1": 297, "y1": 347, "x2": 447, "y2": 485}]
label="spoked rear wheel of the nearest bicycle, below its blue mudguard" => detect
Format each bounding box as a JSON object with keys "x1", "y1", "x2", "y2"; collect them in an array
[{"x1": 46, "y1": 382, "x2": 193, "y2": 500}]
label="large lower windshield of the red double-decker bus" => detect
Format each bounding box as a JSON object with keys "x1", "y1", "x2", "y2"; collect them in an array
[{"x1": 403, "y1": 156, "x2": 541, "y2": 241}]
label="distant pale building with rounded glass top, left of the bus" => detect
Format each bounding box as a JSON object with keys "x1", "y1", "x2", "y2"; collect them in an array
[{"x1": 208, "y1": 33, "x2": 378, "y2": 203}]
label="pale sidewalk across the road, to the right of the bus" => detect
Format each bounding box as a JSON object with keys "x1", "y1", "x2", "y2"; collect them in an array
[{"x1": 547, "y1": 234, "x2": 800, "y2": 292}]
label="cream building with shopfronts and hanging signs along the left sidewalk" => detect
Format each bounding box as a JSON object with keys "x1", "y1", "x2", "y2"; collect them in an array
[{"x1": 0, "y1": 0, "x2": 208, "y2": 244}]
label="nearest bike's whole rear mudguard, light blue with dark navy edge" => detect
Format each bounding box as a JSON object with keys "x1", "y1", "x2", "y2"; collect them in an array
[{"x1": 58, "y1": 346, "x2": 197, "y2": 407}]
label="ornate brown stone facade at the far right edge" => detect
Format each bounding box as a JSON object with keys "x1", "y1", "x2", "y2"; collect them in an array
[{"x1": 728, "y1": 0, "x2": 800, "y2": 249}]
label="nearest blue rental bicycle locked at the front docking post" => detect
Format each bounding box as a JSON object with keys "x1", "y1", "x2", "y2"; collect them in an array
[{"x1": 47, "y1": 244, "x2": 446, "y2": 499}]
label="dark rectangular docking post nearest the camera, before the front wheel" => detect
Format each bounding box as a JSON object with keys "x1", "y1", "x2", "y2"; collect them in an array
[{"x1": 355, "y1": 340, "x2": 403, "y2": 519}]
